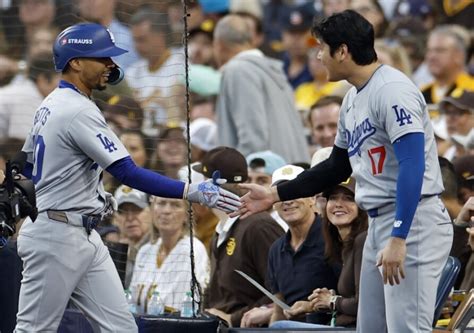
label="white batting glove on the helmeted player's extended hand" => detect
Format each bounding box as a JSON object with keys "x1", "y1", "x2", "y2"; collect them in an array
[{"x1": 184, "y1": 171, "x2": 240, "y2": 213}]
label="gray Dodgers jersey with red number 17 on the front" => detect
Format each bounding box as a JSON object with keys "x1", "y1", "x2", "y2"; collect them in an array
[{"x1": 335, "y1": 65, "x2": 444, "y2": 210}]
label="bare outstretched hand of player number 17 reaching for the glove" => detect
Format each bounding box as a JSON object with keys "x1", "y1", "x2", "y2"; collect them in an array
[{"x1": 230, "y1": 184, "x2": 278, "y2": 219}]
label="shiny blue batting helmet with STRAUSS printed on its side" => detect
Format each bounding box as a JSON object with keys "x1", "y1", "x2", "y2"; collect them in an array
[{"x1": 53, "y1": 23, "x2": 128, "y2": 72}]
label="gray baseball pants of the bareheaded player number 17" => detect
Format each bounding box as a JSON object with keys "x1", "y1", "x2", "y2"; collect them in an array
[{"x1": 357, "y1": 196, "x2": 453, "y2": 333}]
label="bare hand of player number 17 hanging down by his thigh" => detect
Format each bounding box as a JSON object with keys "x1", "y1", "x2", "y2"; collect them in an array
[{"x1": 377, "y1": 237, "x2": 407, "y2": 286}]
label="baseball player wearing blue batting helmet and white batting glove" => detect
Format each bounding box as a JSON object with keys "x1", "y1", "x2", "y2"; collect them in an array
[{"x1": 15, "y1": 23, "x2": 240, "y2": 333}]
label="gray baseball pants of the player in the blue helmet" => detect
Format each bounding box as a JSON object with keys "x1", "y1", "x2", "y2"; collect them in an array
[{"x1": 15, "y1": 213, "x2": 138, "y2": 333}]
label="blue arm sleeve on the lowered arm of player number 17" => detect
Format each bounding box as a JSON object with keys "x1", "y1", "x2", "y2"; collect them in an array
[{"x1": 392, "y1": 133, "x2": 425, "y2": 239}]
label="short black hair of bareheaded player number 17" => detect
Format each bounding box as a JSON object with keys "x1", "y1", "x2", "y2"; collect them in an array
[{"x1": 311, "y1": 9, "x2": 377, "y2": 66}]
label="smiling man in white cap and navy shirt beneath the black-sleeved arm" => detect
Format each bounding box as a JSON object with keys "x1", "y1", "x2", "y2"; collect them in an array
[{"x1": 242, "y1": 165, "x2": 339, "y2": 327}]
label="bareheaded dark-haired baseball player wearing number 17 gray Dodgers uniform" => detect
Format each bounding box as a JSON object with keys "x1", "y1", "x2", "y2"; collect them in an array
[{"x1": 236, "y1": 10, "x2": 453, "y2": 333}]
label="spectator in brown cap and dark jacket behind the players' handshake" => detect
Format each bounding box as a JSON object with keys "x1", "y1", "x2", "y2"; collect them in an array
[{"x1": 194, "y1": 147, "x2": 283, "y2": 327}]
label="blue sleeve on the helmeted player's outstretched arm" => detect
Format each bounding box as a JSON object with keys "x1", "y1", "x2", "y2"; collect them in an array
[{"x1": 106, "y1": 156, "x2": 185, "y2": 199}]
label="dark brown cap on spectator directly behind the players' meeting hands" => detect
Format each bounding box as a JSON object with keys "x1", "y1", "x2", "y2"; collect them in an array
[{"x1": 193, "y1": 146, "x2": 248, "y2": 183}]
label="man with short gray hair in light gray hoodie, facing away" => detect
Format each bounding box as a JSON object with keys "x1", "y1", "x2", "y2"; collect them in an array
[{"x1": 213, "y1": 15, "x2": 309, "y2": 163}]
